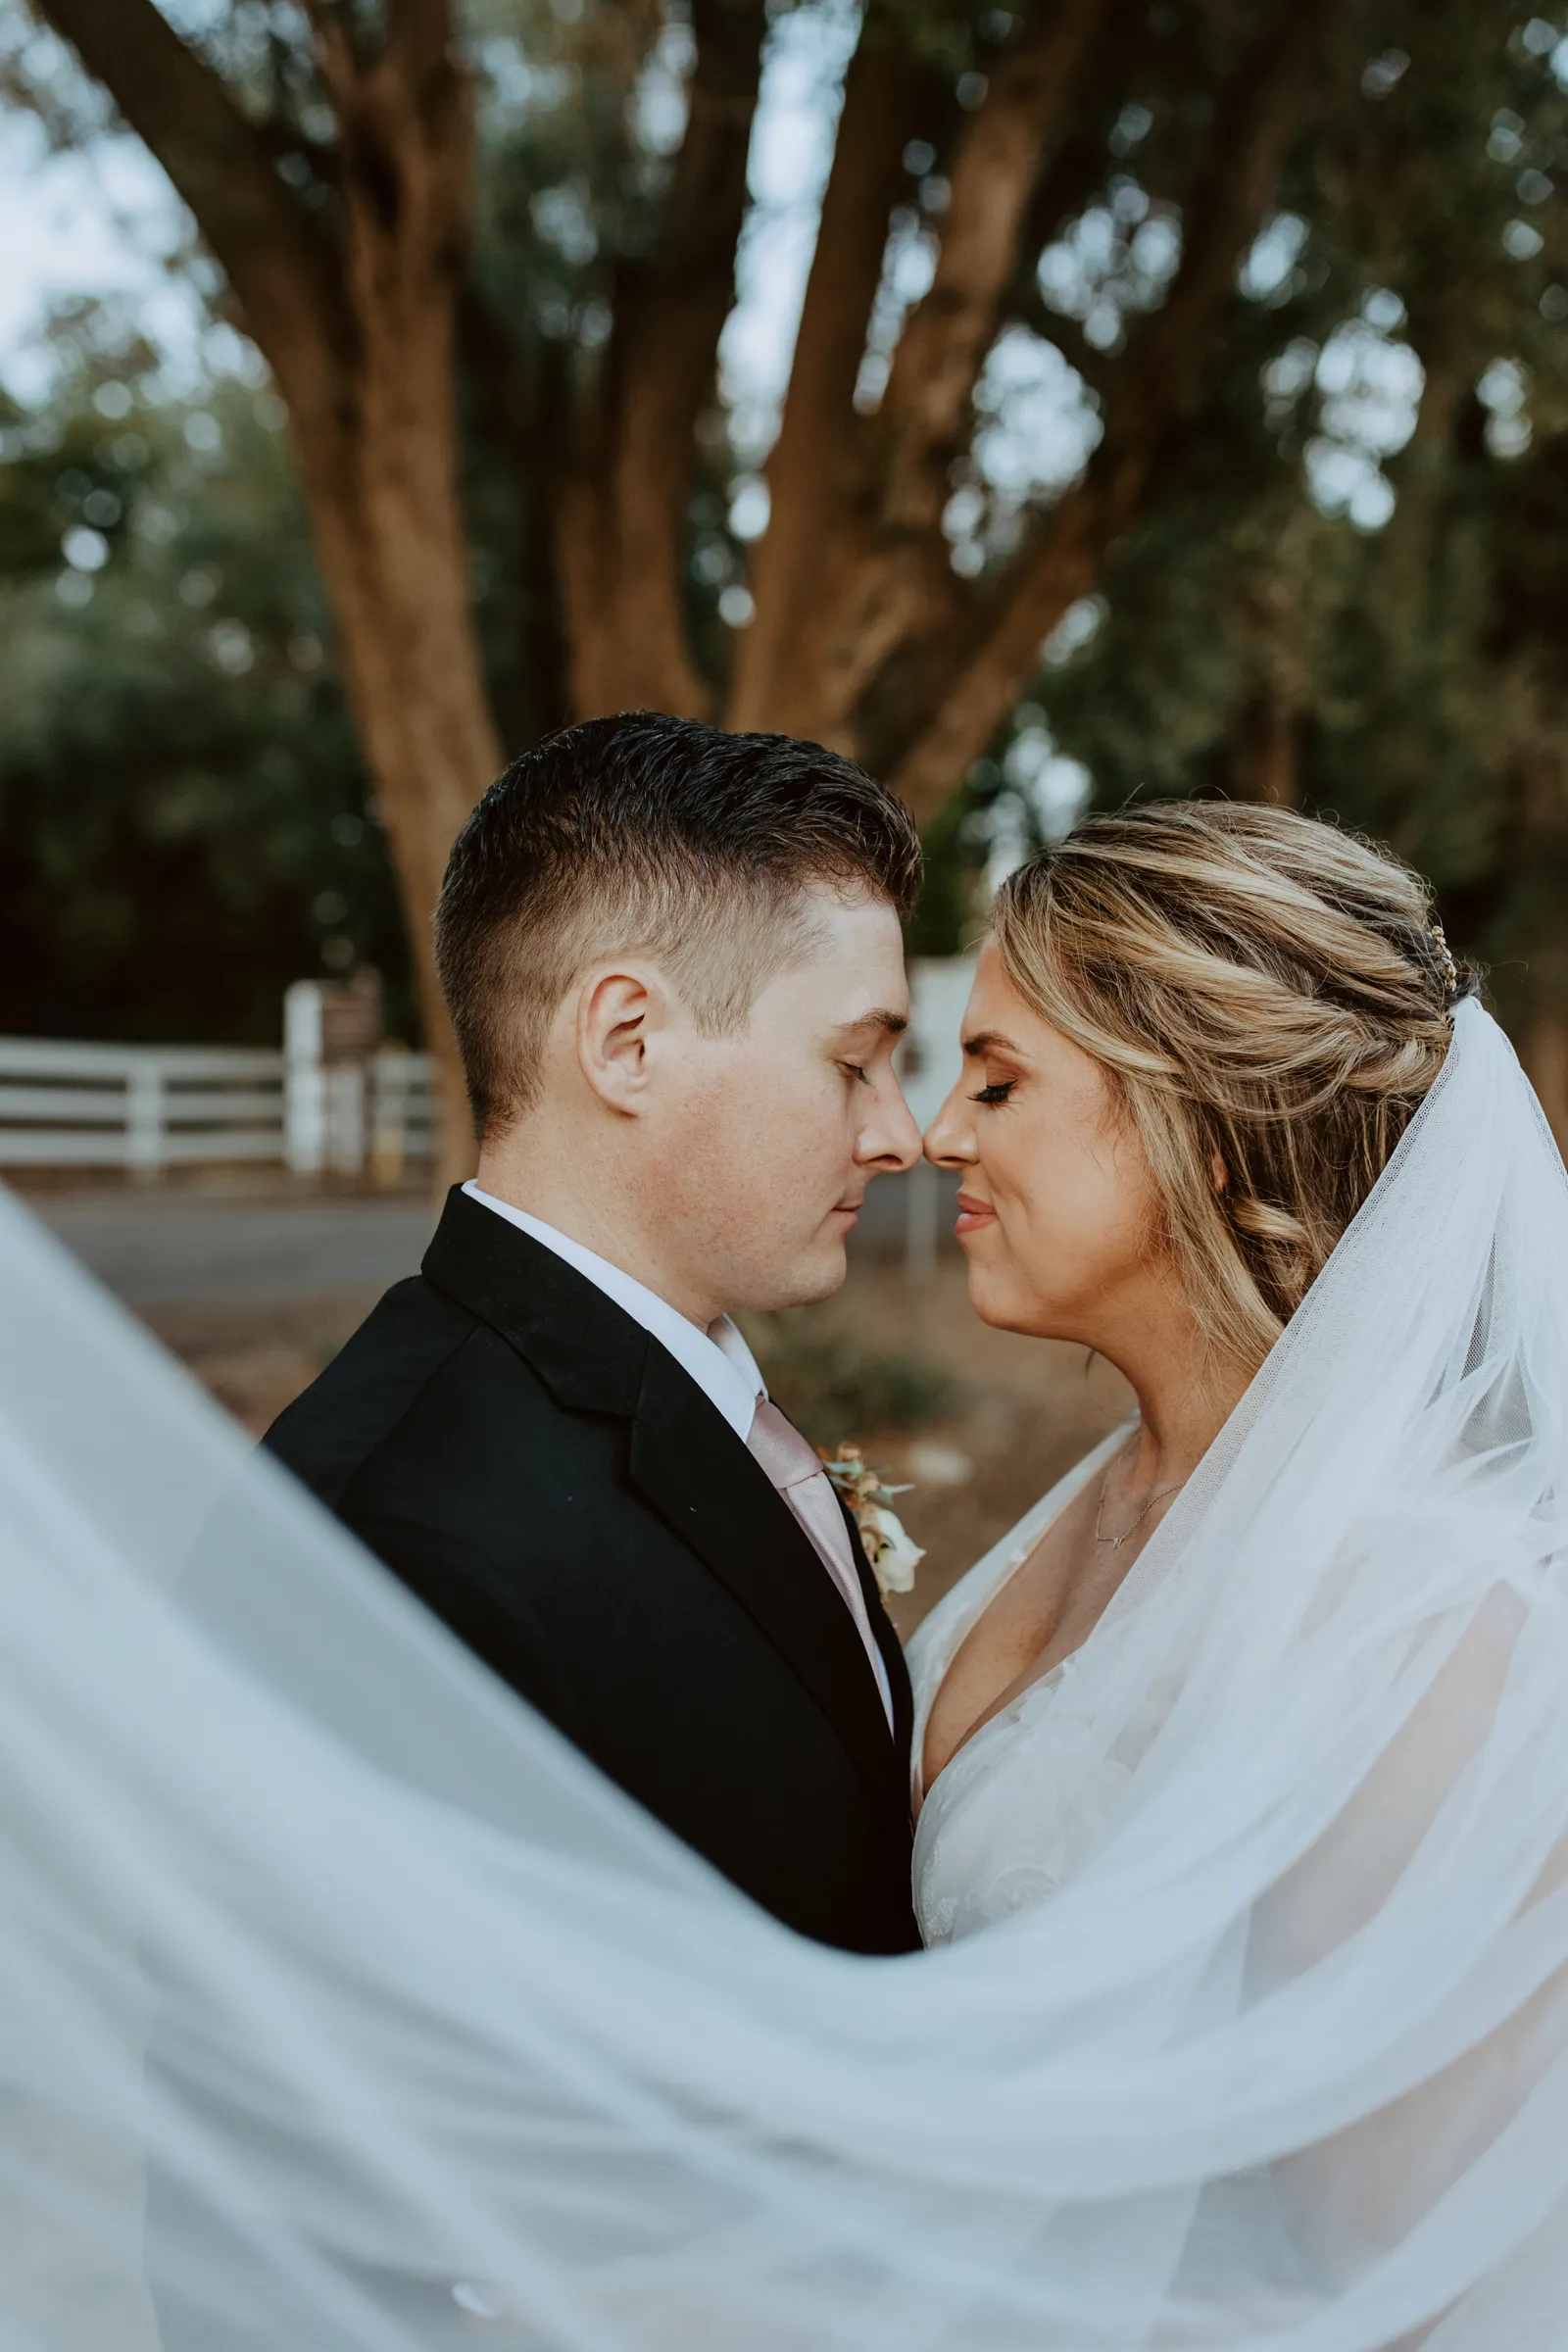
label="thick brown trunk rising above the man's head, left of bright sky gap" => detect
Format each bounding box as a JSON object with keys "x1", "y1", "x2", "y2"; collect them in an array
[{"x1": 562, "y1": 0, "x2": 766, "y2": 710}]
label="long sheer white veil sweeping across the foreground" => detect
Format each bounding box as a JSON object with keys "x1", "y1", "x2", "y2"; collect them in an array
[{"x1": 0, "y1": 1006, "x2": 1568, "y2": 2352}]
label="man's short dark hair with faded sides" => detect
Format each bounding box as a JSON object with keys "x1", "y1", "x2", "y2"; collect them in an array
[{"x1": 435, "y1": 710, "x2": 921, "y2": 1134}]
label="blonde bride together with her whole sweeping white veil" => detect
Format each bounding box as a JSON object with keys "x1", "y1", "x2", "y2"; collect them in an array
[{"x1": 0, "y1": 807, "x2": 1568, "y2": 2352}]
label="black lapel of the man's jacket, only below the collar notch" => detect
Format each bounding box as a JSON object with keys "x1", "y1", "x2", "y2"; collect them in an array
[{"x1": 630, "y1": 1341, "x2": 903, "y2": 1797}]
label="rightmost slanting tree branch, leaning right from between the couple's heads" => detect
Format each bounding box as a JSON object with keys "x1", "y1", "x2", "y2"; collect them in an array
[{"x1": 896, "y1": 0, "x2": 1348, "y2": 813}]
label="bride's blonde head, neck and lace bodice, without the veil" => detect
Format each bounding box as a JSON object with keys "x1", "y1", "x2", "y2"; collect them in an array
[{"x1": 909, "y1": 802, "x2": 1472, "y2": 1942}]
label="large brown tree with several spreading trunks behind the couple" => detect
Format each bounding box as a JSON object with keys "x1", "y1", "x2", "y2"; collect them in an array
[{"x1": 9, "y1": 0, "x2": 1533, "y2": 1164}]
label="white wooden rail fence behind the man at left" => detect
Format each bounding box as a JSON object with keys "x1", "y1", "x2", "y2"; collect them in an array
[{"x1": 0, "y1": 1037, "x2": 430, "y2": 1181}]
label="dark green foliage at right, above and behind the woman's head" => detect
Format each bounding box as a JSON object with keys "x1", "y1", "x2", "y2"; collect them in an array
[{"x1": 938, "y1": 7, "x2": 1568, "y2": 1025}]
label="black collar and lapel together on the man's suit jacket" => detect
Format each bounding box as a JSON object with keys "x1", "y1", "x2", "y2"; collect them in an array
[{"x1": 423, "y1": 1188, "x2": 909, "y2": 1797}]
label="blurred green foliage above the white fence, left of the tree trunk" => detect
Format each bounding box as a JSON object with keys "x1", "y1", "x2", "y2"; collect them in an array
[{"x1": 0, "y1": 318, "x2": 409, "y2": 1042}]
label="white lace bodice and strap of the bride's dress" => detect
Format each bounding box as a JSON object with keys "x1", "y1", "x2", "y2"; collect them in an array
[{"x1": 909, "y1": 1430, "x2": 1128, "y2": 1942}]
